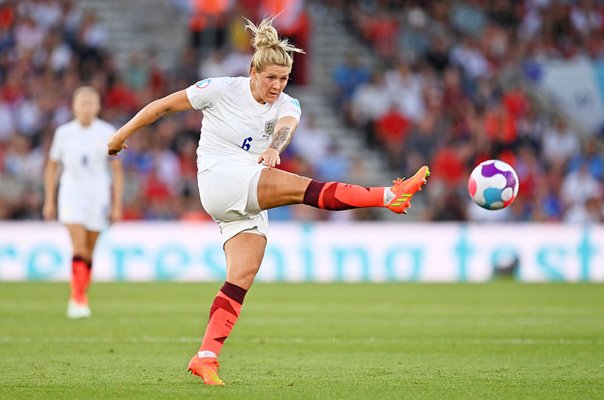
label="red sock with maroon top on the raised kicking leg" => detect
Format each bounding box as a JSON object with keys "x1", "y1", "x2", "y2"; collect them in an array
[{"x1": 304, "y1": 180, "x2": 384, "y2": 210}]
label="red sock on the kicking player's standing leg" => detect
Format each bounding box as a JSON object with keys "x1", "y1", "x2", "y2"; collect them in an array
[{"x1": 199, "y1": 282, "x2": 247, "y2": 357}]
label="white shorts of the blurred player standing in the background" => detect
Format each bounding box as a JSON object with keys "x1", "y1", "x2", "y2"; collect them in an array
[{"x1": 58, "y1": 190, "x2": 110, "y2": 232}]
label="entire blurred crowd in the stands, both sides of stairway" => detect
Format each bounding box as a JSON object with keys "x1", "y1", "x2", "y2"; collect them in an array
[{"x1": 0, "y1": 0, "x2": 604, "y2": 222}]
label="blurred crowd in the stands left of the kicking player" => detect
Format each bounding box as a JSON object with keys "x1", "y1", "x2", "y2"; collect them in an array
[{"x1": 0, "y1": 0, "x2": 308, "y2": 220}]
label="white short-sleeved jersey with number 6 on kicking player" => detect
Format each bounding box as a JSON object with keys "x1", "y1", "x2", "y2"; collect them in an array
[{"x1": 186, "y1": 77, "x2": 301, "y2": 171}]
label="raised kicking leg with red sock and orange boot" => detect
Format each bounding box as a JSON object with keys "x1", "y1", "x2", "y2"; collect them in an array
[{"x1": 258, "y1": 166, "x2": 430, "y2": 214}]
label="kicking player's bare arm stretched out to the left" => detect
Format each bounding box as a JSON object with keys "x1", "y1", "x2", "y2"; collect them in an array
[{"x1": 107, "y1": 90, "x2": 193, "y2": 156}]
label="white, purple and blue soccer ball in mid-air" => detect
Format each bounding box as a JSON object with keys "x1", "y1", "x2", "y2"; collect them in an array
[{"x1": 468, "y1": 160, "x2": 519, "y2": 210}]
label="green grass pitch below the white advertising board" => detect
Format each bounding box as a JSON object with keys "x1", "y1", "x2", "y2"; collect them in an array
[{"x1": 0, "y1": 282, "x2": 604, "y2": 400}]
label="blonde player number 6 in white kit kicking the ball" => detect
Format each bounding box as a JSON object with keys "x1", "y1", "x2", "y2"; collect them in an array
[{"x1": 108, "y1": 18, "x2": 429, "y2": 385}]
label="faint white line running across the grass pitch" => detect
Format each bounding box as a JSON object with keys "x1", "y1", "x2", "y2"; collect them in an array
[{"x1": 0, "y1": 336, "x2": 604, "y2": 346}]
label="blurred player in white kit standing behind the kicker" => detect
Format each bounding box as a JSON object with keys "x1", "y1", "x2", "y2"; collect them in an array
[{"x1": 43, "y1": 86, "x2": 124, "y2": 318}]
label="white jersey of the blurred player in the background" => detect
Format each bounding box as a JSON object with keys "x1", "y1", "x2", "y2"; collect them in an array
[{"x1": 49, "y1": 119, "x2": 115, "y2": 196}]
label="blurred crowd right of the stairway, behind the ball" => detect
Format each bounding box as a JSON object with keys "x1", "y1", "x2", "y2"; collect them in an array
[{"x1": 330, "y1": 0, "x2": 604, "y2": 222}]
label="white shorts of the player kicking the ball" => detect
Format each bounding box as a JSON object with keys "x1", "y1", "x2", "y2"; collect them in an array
[{"x1": 197, "y1": 164, "x2": 268, "y2": 245}]
